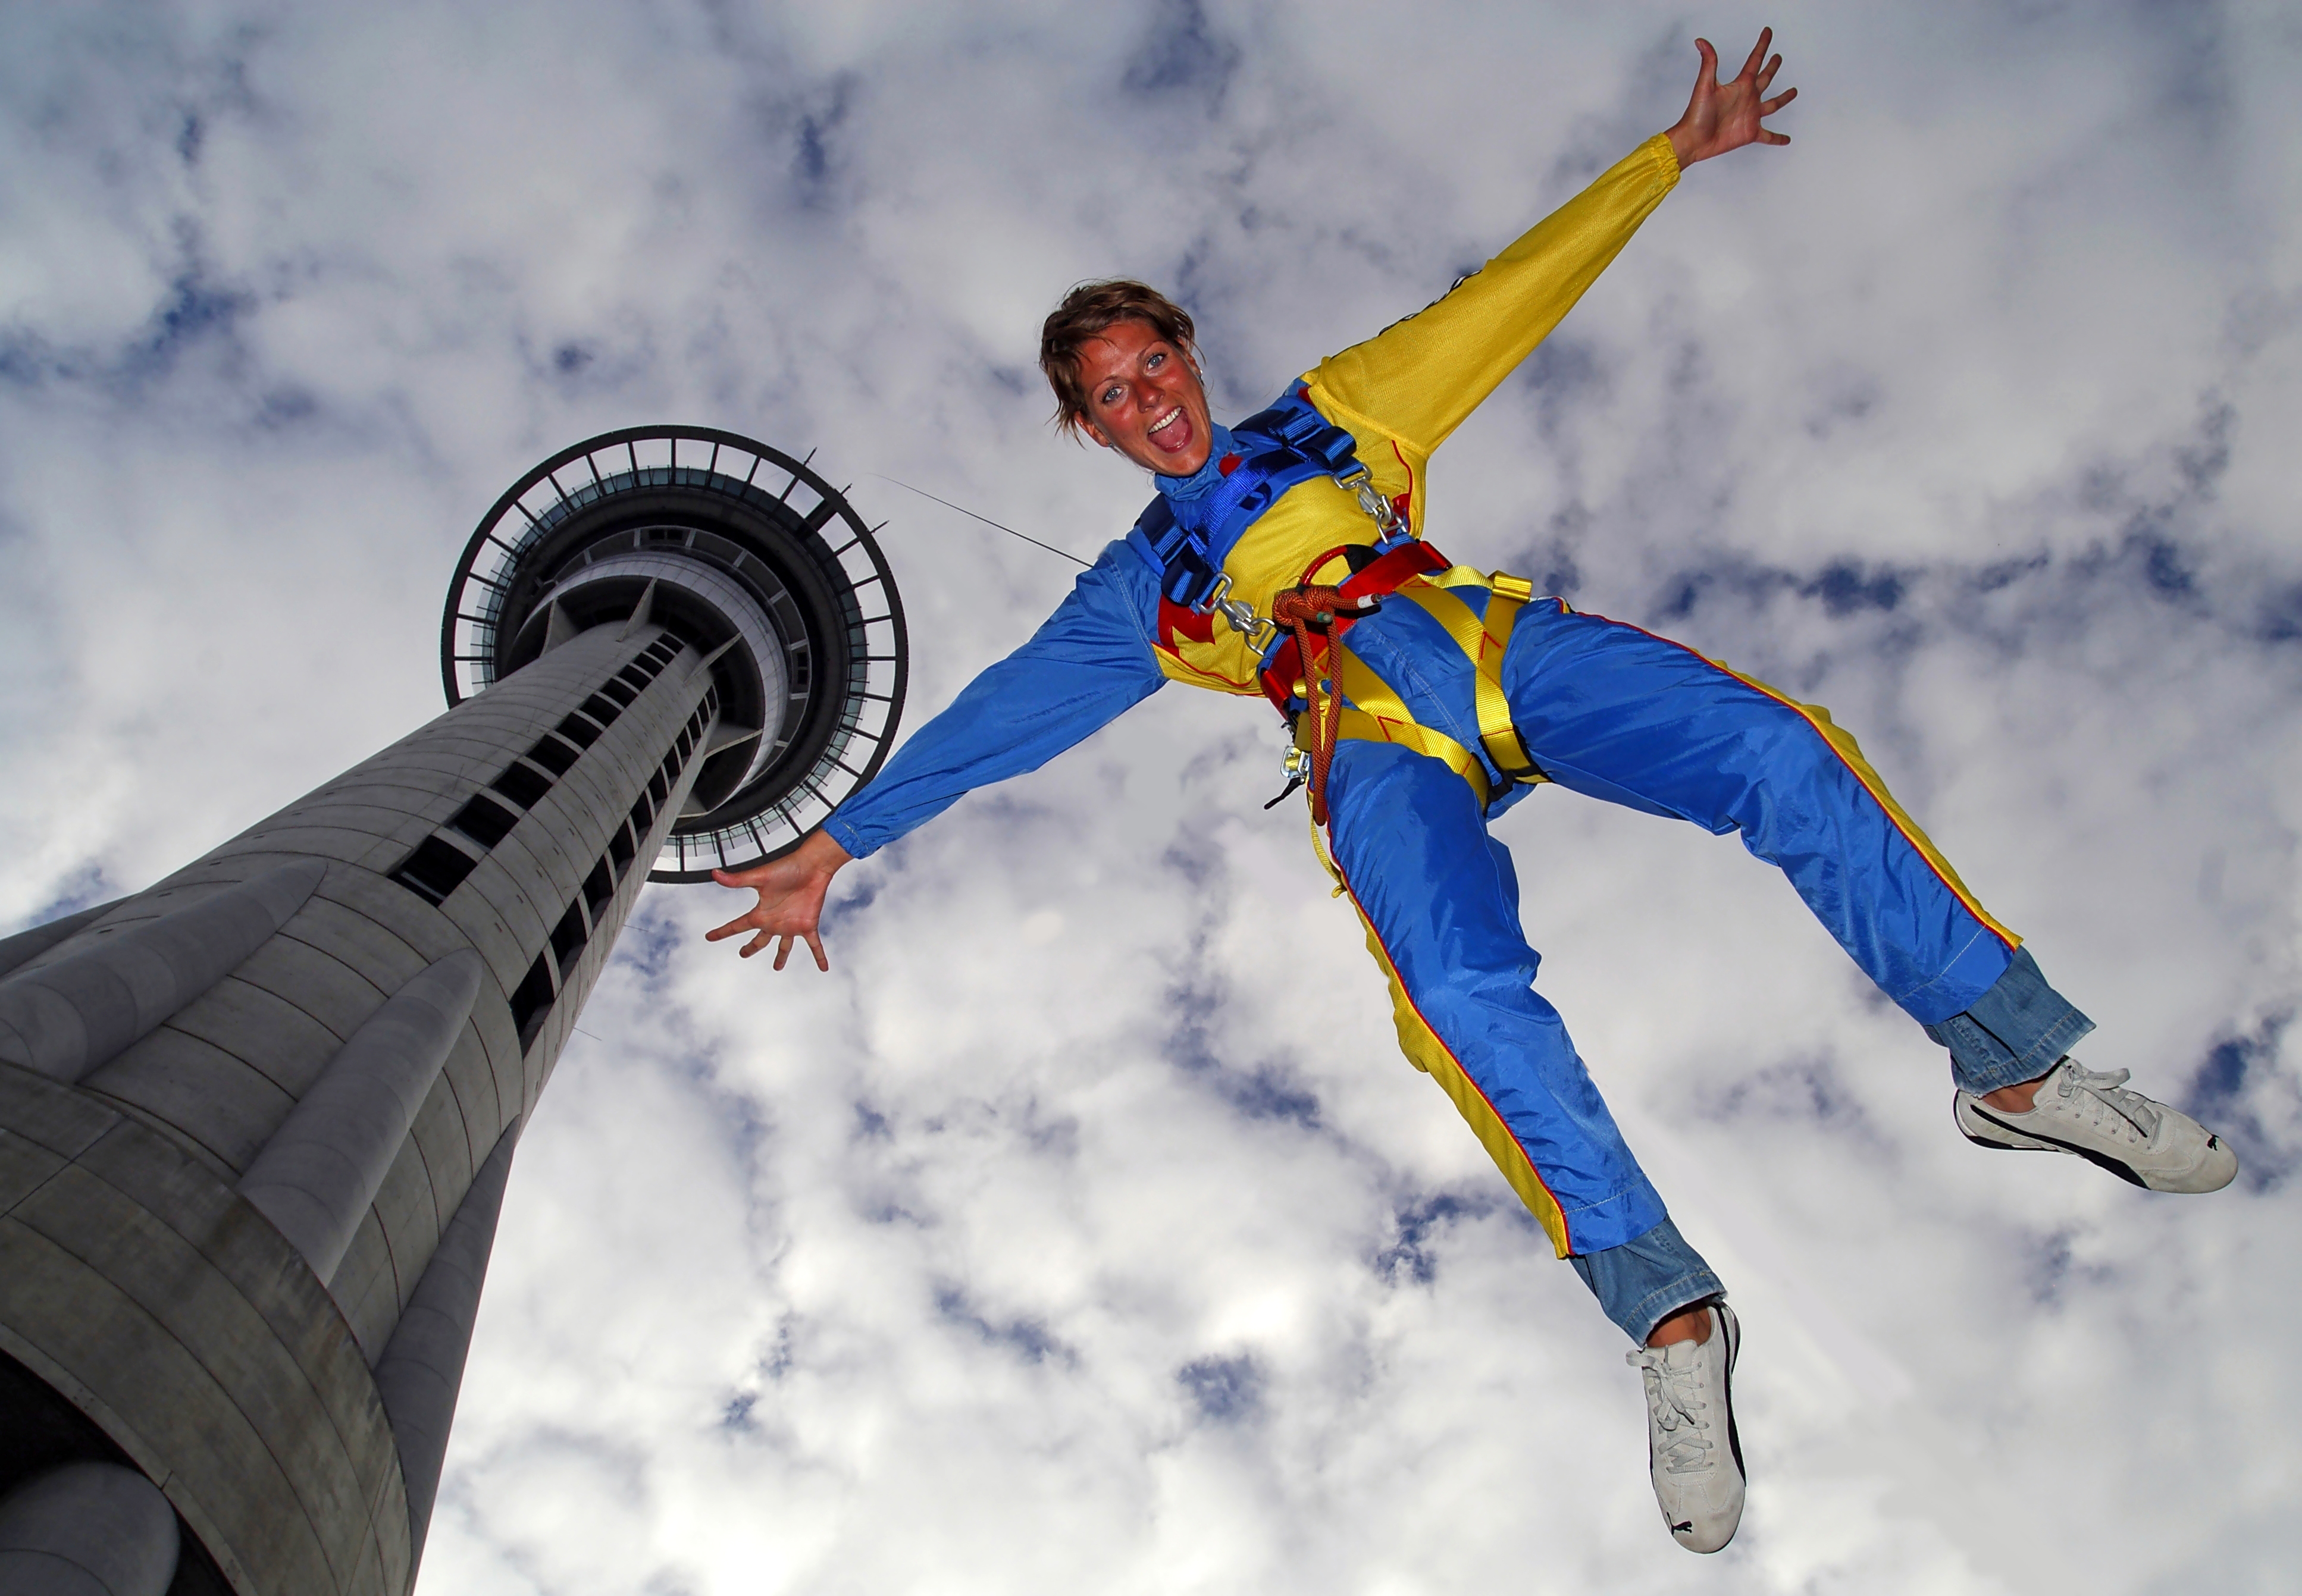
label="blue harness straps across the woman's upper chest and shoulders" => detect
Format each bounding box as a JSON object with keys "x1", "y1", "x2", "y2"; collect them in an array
[{"x1": 1128, "y1": 385, "x2": 1358, "y2": 608}]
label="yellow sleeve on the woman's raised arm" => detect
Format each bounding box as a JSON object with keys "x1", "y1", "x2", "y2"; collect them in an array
[{"x1": 1308, "y1": 134, "x2": 1678, "y2": 456}]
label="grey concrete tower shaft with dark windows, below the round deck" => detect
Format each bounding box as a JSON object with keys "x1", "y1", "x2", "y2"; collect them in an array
[{"x1": 0, "y1": 615, "x2": 721, "y2": 1596}]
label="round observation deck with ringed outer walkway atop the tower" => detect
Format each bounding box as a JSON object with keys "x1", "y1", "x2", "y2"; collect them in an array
[{"x1": 440, "y1": 426, "x2": 909, "y2": 882}]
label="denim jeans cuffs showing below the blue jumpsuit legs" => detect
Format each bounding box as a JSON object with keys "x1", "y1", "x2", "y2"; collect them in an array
[{"x1": 1568, "y1": 949, "x2": 2095, "y2": 1345}]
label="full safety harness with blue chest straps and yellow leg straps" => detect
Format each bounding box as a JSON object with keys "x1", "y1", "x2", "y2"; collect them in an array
[{"x1": 1128, "y1": 385, "x2": 1547, "y2": 827}]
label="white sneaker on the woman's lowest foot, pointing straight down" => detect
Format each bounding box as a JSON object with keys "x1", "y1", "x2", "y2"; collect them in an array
[{"x1": 1623, "y1": 1303, "x2": 1743, "y2": 1552}]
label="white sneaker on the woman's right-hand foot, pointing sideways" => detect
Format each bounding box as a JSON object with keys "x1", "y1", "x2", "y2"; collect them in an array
[{"x1": 1952, "y1": 1059, "x2": 2238, "y2": 1193}]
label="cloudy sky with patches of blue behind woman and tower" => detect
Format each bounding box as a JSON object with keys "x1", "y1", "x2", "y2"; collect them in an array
[{"x1": 0, "y1": 0, "x2": 2302, "y2": 1596}]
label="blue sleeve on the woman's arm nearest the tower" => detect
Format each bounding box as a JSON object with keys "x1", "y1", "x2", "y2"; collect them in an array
[{"x1": 824, "y1": 541, "x2": 1167, "y2": 859}]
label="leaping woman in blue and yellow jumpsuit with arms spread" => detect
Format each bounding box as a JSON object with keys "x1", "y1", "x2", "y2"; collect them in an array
[{"x1": 709, "y1": 32, "x2": 2238, "y2": 1552}]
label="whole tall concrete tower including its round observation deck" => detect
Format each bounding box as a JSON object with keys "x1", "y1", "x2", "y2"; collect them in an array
[{"x1": 0, "y1": 426, "x2": 905, "y2": 1596}]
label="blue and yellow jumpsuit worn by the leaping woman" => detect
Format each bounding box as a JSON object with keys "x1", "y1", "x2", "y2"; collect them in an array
[{"x1": 824, "y1": 136, "x2": 2090, "y2": 1340}]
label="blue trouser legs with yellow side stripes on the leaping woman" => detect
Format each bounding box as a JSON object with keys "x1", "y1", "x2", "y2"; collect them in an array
[{"x1": 1328, "y1": 601, "x2": 2093, "y2": 1340}]
